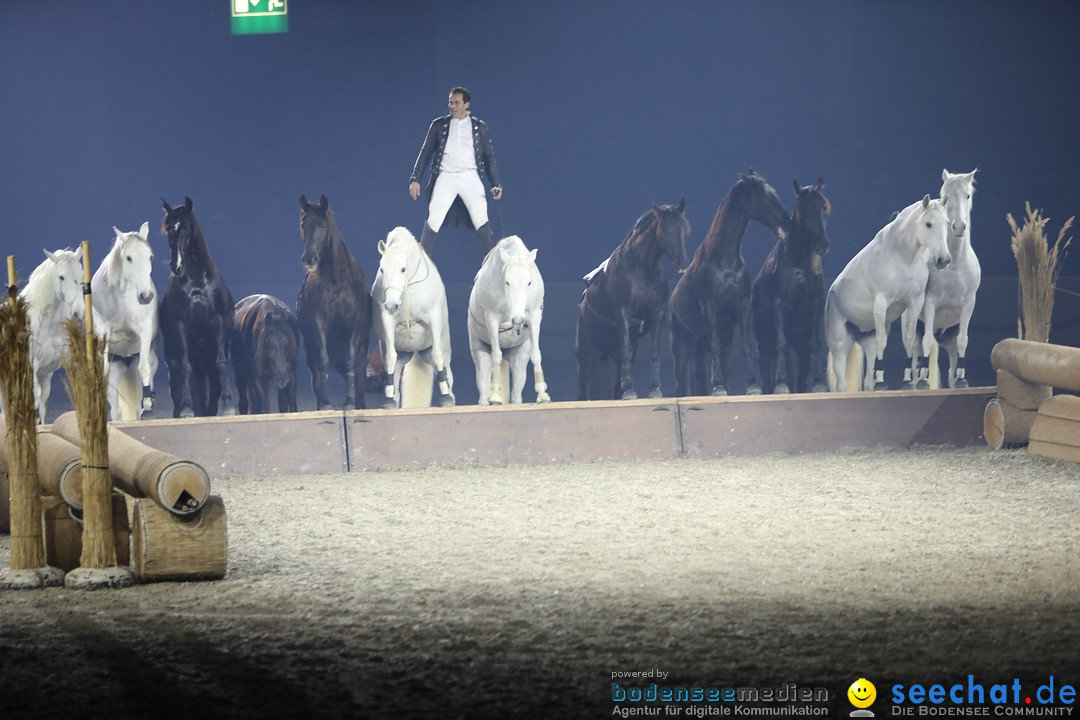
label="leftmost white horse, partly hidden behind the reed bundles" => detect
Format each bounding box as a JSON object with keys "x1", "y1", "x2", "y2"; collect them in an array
[{"x1": 19, "y1": 249, "x2": 86, "y2": 423}]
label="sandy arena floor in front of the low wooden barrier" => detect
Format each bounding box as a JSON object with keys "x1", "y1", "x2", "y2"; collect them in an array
[{"x1": 0, "y1": 448, "x2": 1080, "y2": 720}]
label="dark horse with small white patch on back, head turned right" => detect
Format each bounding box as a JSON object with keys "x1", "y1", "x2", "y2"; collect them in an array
[{"x1": 575, "y1": 200, "x2": 690, "y2": 400}]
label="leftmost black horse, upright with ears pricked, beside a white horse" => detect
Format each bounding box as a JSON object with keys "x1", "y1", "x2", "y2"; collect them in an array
[{"x1": 159, "y1": 198, "x2": 237, "y2": 418}]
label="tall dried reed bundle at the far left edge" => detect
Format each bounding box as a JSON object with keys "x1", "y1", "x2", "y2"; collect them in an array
[{"x1": 0, "y1": 290, "x2": 45, "y2": 570}]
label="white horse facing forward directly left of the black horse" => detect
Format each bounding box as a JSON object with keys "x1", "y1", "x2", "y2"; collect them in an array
[{"x1": 91, "y1": 222, "x2": 158, "y2": 420}]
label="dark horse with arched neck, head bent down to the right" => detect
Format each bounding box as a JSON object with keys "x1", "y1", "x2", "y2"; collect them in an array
[{"x1": 671, "y1": 168, "x2": 788, "y2": 396}]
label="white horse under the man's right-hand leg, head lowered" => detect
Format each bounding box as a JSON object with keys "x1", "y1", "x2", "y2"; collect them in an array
[{"x1": 469, "y1": 235, "x2": 551, "y2": 405}]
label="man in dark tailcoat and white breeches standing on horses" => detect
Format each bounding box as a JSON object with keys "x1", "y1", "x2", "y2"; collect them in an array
[{"x1": 408, "y1": 86, "x2": 502, "y2": 255}]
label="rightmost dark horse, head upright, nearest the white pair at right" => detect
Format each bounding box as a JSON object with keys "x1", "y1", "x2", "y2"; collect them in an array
[{"x1": 753, "y1": 179, "x2": 832, "y2": 393}]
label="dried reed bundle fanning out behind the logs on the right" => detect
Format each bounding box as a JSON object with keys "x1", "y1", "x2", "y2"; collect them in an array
[{"x1": 1005, "y1": 203, "x2": 1075, "y2": 342}]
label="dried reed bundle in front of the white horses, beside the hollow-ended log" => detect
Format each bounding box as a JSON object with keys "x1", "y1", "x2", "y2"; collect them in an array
[{"x1": 60, "y1": 320, "x2": 117, "y2": 568}]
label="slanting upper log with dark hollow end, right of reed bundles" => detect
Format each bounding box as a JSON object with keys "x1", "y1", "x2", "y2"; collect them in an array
[{"x1": 52, "y1": 412, "x2": 210, "y2": 515}]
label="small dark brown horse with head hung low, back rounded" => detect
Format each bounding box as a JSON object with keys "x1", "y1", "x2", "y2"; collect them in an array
[{"x1": 231, "y1": 295, "x2": 300, "y2": 415}]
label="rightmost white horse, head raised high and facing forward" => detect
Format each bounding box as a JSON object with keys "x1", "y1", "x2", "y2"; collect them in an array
[{"x1": 913, "y1": 168, "x2": 983, "y2": 388}]
